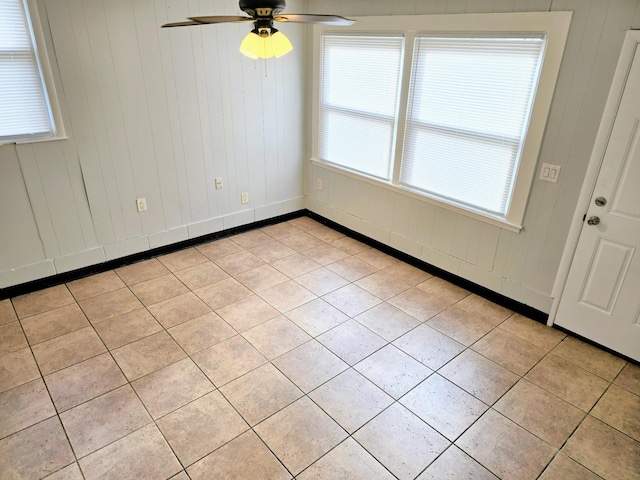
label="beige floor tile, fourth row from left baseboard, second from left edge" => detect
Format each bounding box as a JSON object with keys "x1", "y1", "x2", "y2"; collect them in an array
[{"x1": 44, "y1": 353, "x2": 127, "y2": 412}]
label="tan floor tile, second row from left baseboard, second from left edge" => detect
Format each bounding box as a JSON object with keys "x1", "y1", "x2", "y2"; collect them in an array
[{"x1": 21, "y1": 303, "x2": 89, "y2": 345}]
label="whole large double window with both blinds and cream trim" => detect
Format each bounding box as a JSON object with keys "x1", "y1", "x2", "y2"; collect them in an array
[{"x1": 313, "y1": 13, "x2": 570, "y2": 229}]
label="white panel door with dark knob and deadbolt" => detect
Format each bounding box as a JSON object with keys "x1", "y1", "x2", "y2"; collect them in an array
[{"x1": 555, "y1": 37, "x2": 640, "y2": 360}]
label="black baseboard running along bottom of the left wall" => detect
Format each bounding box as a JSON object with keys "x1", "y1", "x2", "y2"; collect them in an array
[{"x1": 0, "y1": 210, "x2": 309, "y2": 300}]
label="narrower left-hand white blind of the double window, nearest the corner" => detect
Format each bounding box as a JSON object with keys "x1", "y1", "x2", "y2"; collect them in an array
[{"x1": 319, "y1": 33, "x2": 404, "y2": 180}]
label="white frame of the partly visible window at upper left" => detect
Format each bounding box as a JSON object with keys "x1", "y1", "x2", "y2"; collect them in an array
[{"x1": 0, "y1": 0, "x2": 68, "y2": 146}]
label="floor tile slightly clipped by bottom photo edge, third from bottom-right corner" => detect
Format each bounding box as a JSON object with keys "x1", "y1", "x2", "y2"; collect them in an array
[{"x1": 456, "y1": 410, "x2": 556, "y2": 479}]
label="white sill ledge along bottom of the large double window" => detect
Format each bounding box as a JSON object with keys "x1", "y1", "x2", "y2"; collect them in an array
[{"x1": 310, "y1": 158, "x2": 523, "y2": 233}]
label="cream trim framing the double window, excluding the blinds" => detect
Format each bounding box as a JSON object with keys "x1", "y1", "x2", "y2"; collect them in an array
[{"x1": 311, "y1": 12, "x2": 572, "y2": 232}]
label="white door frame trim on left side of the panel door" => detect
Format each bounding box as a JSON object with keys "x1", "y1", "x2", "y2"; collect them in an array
[{"x1": 547, "y1": 30, "x2": 640, "y2": 326}]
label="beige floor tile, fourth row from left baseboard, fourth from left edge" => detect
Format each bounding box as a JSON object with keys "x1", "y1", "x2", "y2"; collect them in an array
[{"x1": 168, "y1": 312, "x2": 236, "y2": 355}]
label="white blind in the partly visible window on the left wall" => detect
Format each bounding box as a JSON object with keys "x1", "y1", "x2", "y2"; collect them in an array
[{"x1": 0, "y1": 0, "x2": 54, "y2": 143}]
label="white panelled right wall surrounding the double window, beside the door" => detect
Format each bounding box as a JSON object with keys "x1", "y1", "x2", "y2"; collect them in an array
[{"x1": 305, "y1": 0, "x2": 640, "y2": 312}]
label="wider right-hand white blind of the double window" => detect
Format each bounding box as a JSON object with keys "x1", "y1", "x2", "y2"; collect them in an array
[{"x1": 400, "y1": 36, "x2": 544, "y2": 217}]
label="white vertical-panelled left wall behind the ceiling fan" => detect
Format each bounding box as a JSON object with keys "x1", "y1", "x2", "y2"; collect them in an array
[{"x1": 0, "y1": 0, "x2": 305, "y2": 288}]
